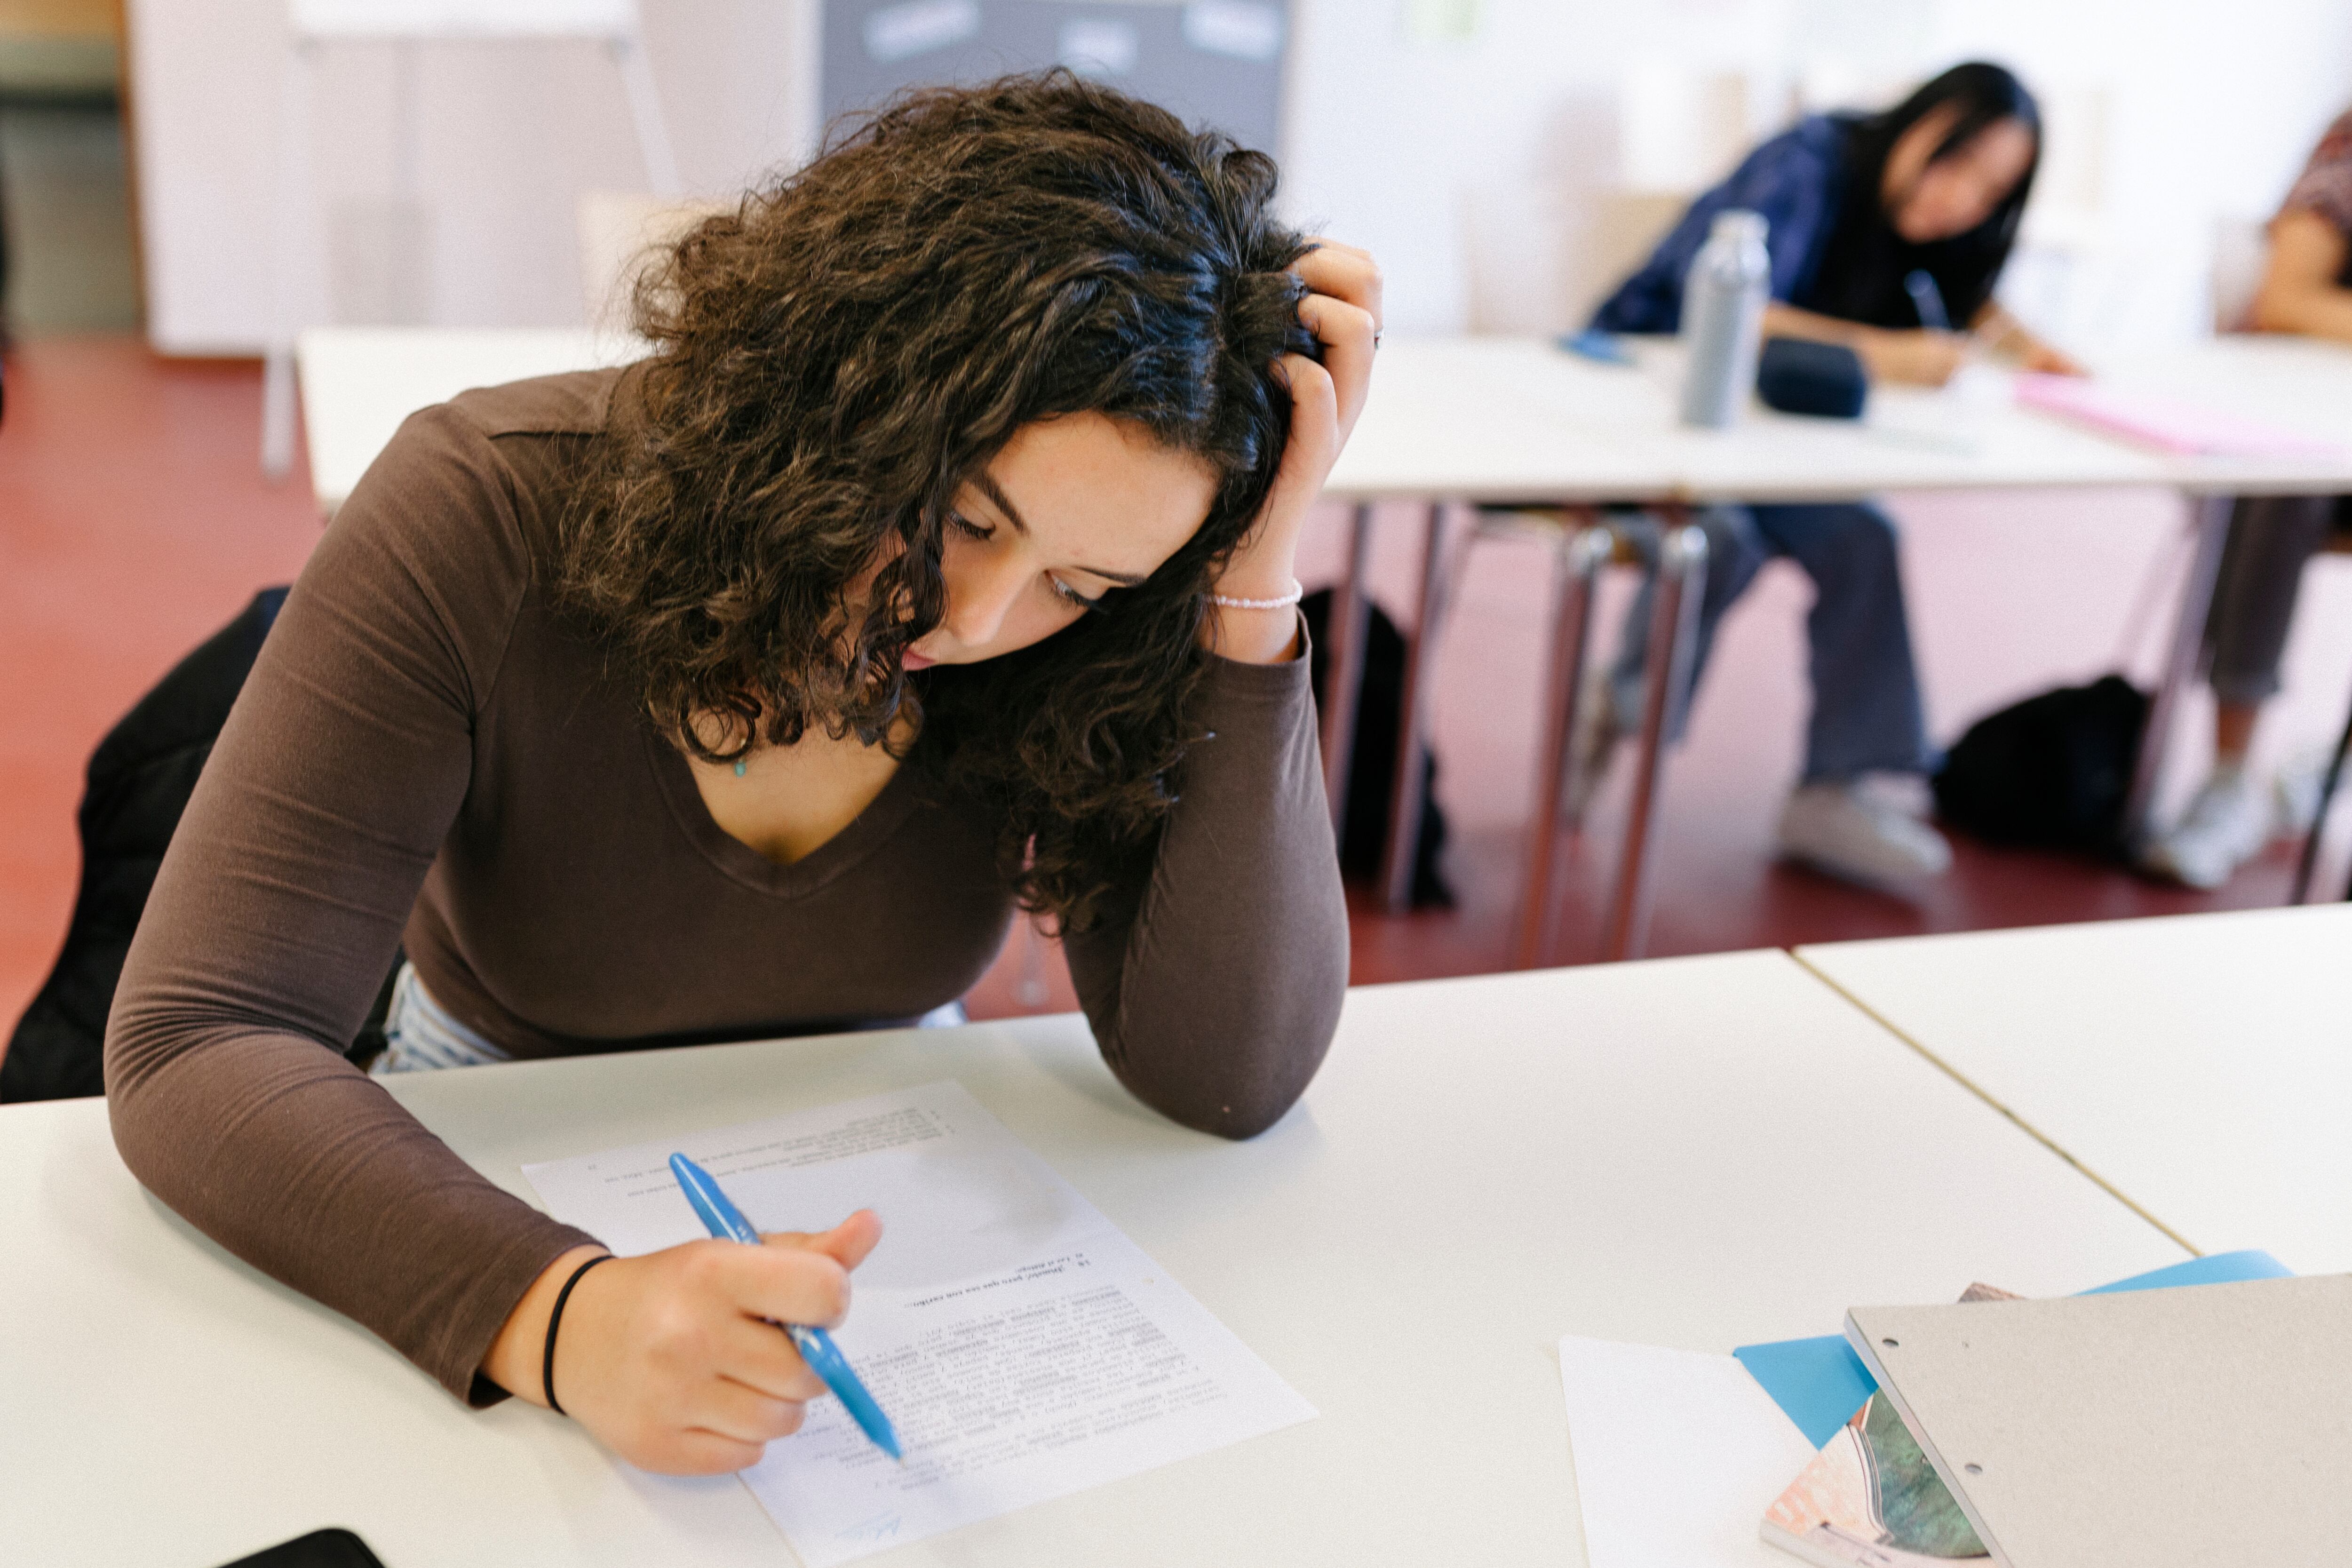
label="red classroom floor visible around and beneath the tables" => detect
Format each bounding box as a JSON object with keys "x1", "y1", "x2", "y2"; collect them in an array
[{"x1": 0, "y1": 339, "x2": 2352, "y2": 1053}]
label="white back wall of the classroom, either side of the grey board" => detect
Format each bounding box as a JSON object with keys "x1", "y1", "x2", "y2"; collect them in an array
[{"x1": 129, "y1": 0, "x2": 2352, "y2": 353}]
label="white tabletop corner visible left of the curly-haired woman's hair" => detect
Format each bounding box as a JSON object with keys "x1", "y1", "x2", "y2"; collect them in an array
[{"x1": 294, "y1": 327, "x2": 644, "y2": 517}]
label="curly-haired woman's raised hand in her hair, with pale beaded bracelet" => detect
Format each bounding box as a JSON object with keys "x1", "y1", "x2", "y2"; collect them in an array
[{"x1": 1204, "y1": 240, "x2": 1381, "y2": 663}]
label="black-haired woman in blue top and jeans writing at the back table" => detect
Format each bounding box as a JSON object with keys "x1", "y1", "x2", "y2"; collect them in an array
[{"x1": 1571, "y1": 64, "x2": 2074, "y2": 882}]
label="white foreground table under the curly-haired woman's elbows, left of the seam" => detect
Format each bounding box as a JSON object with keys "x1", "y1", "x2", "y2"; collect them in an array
[{"x1": 0, "y1": 952, "x2": 2183, "y2": 1568}]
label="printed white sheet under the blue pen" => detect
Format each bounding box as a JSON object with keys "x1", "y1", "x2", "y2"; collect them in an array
[{"x1": 524, "y1": 1084, "x2": 1317, "y2": 1568}]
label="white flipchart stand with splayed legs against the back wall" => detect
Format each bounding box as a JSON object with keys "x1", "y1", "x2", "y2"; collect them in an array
[{"x1": 261, "y1": 0, "x2": 684, "y2": 479}]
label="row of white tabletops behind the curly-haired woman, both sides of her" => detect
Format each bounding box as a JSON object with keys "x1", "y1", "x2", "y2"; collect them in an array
[{"x1": 296, "y1": 327, "x2": 2352, "y2": 524}]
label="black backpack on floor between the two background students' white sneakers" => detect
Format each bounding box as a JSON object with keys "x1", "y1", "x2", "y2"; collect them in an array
[{"x1": 1936, "y1": 675, "x2": 2147, "y2": 856}]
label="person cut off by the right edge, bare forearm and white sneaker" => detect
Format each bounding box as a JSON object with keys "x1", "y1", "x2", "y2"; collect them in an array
[{"x1": 2140, "y1": 113, "x2": 2352, "y2": 889}]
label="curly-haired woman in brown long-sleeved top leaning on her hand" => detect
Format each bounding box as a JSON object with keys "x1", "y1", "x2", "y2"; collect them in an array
[{"x1": 106, "y1": 75, "x2": 1381, "y2": 1472}]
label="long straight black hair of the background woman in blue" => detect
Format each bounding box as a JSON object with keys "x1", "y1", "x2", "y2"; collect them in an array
[{"x1": 1802, "y1": 61, "x2": 2042, "y2": 329}]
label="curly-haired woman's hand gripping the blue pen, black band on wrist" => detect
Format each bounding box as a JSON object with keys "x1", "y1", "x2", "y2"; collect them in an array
[{"x1": 482, "y1": 1208, "x2": 882, "y2": 1476}]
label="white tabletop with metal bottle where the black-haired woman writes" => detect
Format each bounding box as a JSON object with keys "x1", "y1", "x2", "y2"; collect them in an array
[{"x1": 1324, "y1": 336, "x2": 2352, "y2": 503}]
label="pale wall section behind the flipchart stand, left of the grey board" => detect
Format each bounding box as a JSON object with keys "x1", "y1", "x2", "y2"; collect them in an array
[{"x1": 129, "y1": 0, "x2": 814, "y2": 355}]
